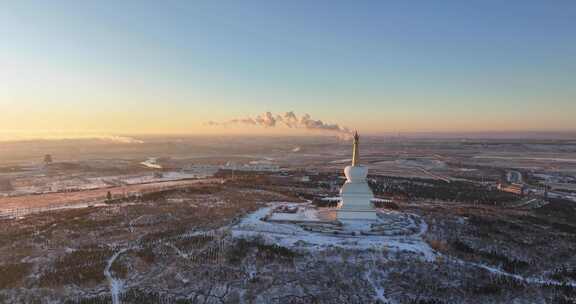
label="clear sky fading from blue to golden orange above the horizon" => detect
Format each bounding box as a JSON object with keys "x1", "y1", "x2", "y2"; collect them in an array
[{"x1": 0, "y1": 0, "x2": 576, "y2": 134}]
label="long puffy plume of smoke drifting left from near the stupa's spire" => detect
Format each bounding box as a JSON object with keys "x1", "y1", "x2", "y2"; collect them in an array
[{"x1": 206, "y1": 111, "x2": 351, "y2": 137}]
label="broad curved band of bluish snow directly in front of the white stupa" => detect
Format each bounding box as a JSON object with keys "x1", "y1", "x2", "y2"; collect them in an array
[{"x1": 231, "y1": 203, "x2": 436, "y2": 261}]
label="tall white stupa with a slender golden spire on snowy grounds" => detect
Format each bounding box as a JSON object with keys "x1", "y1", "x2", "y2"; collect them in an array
[{"x1": 338, "y1": 132, "x2": 378, "y2": 221}]
